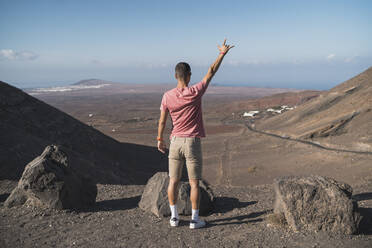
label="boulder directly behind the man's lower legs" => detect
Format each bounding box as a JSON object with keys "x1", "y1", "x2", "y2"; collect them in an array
[{"x1": 139, "y1": 172, "x2": 214, "y2": 217}]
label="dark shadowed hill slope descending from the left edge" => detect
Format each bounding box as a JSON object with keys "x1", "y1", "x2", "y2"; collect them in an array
[{"x1": 0, "y1": 81, "x2": 167, "y2": 184}]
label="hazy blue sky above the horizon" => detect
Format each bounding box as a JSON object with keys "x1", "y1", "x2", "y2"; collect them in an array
[{"x1": 0, "y1": 0, "x2": 372, "y2": 90}]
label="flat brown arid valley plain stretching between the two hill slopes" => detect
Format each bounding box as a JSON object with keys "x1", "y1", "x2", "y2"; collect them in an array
[{"x1": 29, "y1": 77, "x2": 372, "y2": 186}]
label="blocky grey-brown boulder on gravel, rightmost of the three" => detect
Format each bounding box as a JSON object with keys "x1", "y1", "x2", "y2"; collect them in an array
[{"x1": 274, "y1": 176, "x2": 360, "y2": 234}]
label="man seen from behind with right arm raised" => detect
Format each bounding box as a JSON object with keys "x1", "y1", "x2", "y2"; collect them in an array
[{"x1": 157, "y1": 39, "x2": 234, "y2": 229}]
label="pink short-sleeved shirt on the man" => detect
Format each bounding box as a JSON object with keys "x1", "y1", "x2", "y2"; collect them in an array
[{"x1": 160, "y1": 81, "x2": 207, "y2": 137}]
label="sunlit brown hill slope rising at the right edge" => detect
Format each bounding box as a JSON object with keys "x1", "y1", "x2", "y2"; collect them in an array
[{"x1": 256, "y1": 67, "x2": 372, "y2": 151}]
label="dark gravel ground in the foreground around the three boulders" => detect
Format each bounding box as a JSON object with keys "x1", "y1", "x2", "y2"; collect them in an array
[{"x1": 0, "y1": 180, "x2": 372, "y2": 248}]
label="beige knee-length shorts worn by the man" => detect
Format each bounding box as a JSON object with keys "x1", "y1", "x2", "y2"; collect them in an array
[{"x1": 168, "y1": 136, "x2": 203, "y2": 180}]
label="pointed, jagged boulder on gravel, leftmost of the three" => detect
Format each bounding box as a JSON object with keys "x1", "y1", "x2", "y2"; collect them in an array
[{"x1": 4, "y1": 145, "x2": 97, "y2": 209}]
